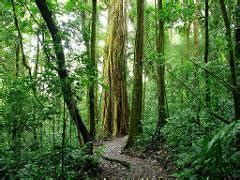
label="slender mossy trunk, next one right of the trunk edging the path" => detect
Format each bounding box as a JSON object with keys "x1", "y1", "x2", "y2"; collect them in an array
[{"x1": 155, "y1": 0, "x2": 167, "y2": 137}]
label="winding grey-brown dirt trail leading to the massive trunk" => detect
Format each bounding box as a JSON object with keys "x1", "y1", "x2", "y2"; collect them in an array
[{"x1": 101, "y1": 136, "x2": 171, "y2": 179}]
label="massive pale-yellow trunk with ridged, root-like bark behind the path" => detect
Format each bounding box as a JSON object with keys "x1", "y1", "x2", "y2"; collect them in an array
[{"x1": 102, "y1": 0, "x2": 128, "y2": 136}]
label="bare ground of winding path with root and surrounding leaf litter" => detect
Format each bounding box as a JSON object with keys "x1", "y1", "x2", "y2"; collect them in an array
[{"x1": 96, "y1": 136, "x2": 175, "y2": 179}]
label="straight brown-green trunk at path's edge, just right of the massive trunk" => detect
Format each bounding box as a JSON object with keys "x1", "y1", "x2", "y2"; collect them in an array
[{"x1": 127, "y1": 0, "x2": 144, "y2": 146}]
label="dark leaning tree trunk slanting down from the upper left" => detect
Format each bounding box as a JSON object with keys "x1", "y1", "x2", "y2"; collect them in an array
[{"x1": 35, "y1": 0, "x2": 92, "y2": 147}]
